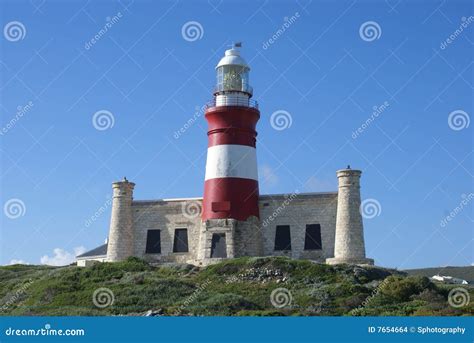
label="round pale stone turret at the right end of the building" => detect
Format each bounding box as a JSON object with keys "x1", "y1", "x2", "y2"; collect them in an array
[{"x1": 326, "y1": 166, "x2": 374, "y2": 264}]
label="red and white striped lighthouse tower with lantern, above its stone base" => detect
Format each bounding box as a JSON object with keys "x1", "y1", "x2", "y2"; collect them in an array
[{"x1": 202, "y1": 43, "x2": 260, "y2": 221}]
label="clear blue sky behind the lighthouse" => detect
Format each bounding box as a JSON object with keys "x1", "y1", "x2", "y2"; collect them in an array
[{"x1": 0, "y1": 0, "x2": 474, "y2": 269}]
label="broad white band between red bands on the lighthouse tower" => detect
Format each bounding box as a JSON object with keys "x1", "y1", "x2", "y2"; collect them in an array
[{"x1": 205, "y1": 144, "x2": 258, "y2": 180}]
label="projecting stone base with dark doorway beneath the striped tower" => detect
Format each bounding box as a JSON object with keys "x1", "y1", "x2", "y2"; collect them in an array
[{"x1": 197, "y1": 217, "x2": 263, "y2": 265}]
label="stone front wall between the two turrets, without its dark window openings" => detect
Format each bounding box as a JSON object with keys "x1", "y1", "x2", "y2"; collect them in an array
[{"x1": 128, "y1": 193, "x2": 337, "y2": 264}]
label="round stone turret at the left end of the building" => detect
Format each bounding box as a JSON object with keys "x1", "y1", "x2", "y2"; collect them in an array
[{"x1": 107, "y1": 178, "x2": 135, "y2": 262}]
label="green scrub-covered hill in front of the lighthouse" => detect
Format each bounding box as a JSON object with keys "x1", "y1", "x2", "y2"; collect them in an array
[{"x1": 0, "y1": 257, "x2": 474, "y2": 316}]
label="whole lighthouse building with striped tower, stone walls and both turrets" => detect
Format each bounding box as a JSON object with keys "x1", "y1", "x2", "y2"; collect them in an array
[{"x1": 77, "y1": 44, "x2": 373, "y2": 266}]
